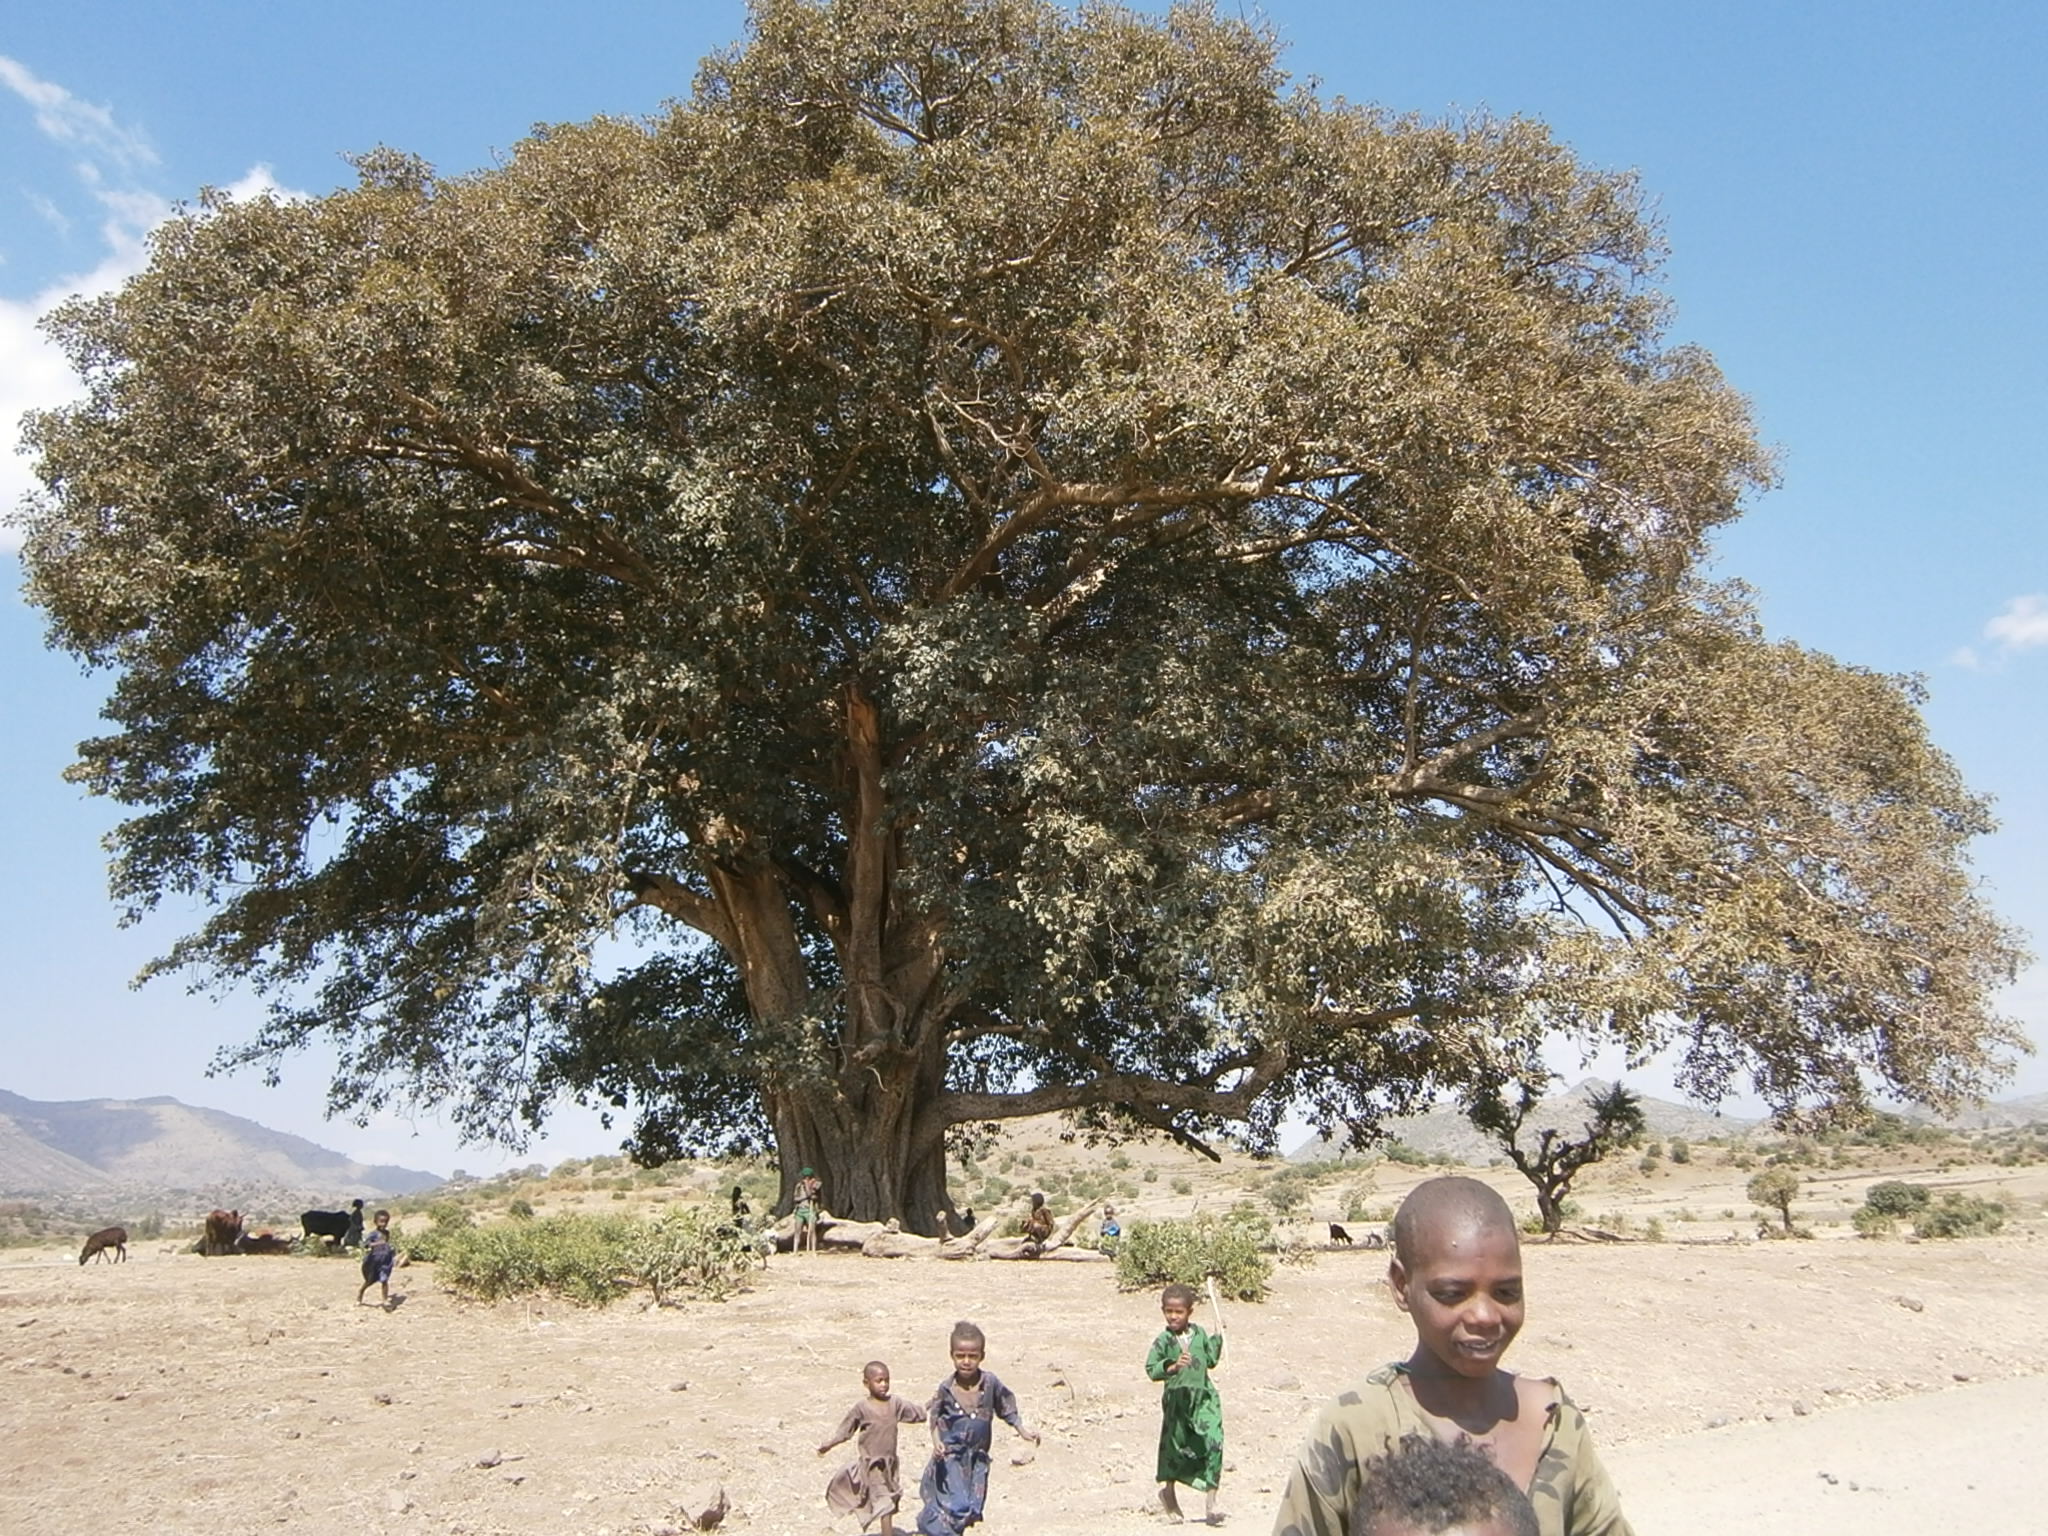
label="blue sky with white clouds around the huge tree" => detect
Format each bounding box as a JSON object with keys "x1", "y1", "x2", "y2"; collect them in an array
[{"x1": 0, "y1": 0, "x2": 2048, "y2": 1171}]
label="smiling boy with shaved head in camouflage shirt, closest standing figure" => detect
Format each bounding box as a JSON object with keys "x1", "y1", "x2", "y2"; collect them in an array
[{"x1": 1274, "y1": 1178, "x2": 1630, "y2": 1536}]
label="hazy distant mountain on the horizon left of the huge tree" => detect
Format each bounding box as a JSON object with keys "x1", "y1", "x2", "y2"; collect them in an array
[{"x1": 0, "y1": 1090, "x2": 442, "y2": 1200}]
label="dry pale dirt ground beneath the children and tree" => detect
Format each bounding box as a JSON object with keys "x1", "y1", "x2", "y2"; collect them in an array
[{"x1": 12, "y1": 1169, "x2": 2048, "y2": 1536}]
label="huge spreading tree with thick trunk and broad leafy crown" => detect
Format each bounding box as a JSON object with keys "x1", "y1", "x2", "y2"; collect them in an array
[{"x1": 25, "y1": 0, "x2": 2017, "y2": 1227}]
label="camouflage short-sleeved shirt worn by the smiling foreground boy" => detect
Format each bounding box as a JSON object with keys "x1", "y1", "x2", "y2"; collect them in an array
[{"x1": 1274, "y1": 1364, "x2": 1634, "y2": 1536}]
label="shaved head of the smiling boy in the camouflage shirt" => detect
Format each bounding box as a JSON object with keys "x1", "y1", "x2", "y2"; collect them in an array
[{"x1": 1386, "y1": 1178, "x2": 1522, "y2": 1376}]
